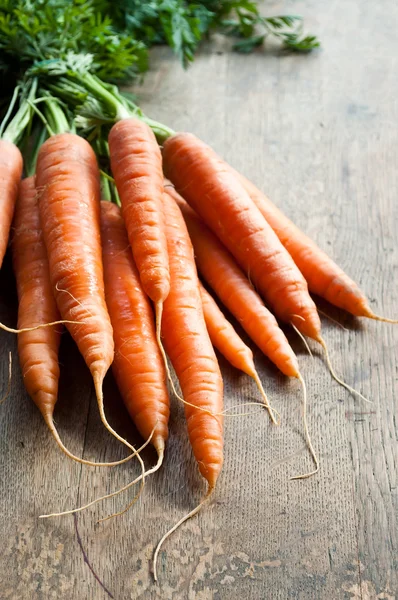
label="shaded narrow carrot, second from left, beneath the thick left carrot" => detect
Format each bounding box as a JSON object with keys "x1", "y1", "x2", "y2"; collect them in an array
[{"x1": 12, "y1": 177, "x2": 62, "y2": 421}]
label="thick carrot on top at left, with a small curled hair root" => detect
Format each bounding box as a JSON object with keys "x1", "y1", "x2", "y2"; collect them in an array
[{"x1": 36, "y1": 133, "x2": 114, "y2": 382}]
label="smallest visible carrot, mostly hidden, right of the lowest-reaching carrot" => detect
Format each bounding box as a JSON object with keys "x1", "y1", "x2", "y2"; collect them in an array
[{"x1": 200, "y1": 284, "x2": 278, "y2": 423}]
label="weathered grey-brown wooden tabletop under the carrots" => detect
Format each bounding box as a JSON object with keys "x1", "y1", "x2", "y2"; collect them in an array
[{"x1": 0, "y1": 0, "x2": 398, "y2": 600}]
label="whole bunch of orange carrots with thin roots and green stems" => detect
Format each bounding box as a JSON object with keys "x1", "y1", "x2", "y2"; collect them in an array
[{"x1": 0, "y1": 74, "x2": 395, "y2": 579}]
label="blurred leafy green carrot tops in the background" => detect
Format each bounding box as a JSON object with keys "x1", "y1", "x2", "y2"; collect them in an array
[{"x1": 0, "y1": 0, "x2": 319, "y2": 80}]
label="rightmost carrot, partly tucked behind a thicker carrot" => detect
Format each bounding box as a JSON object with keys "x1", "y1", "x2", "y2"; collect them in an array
[{"x1": 231, "y1": 167, "x2": 398, "y2": 323}]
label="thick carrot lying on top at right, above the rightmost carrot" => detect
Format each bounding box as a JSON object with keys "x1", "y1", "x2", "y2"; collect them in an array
[{"x1": 163, "y1": 133, "x2": 321, "y2": 341}]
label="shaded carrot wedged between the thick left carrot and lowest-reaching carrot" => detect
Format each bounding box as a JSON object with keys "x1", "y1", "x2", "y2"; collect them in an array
[{"x1": 101, "y1": 201, "x2": 169, "y2": 453}]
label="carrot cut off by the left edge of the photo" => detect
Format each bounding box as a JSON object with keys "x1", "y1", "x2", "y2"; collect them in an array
[{"x1": 0, "y1": 139, "x2": 23, "y2": 268}]
